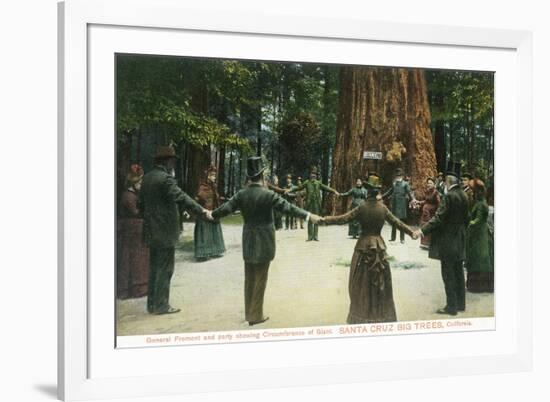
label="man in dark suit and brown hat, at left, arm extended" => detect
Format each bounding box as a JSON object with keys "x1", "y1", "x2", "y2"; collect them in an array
[{"x1": 140, "y1": 146, "x2": 212, "y2": 314}]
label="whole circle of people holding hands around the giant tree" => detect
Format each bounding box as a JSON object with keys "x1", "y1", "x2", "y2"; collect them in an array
[{"x1": 117, "y1": 146, "x2": 493, "y2": 326}]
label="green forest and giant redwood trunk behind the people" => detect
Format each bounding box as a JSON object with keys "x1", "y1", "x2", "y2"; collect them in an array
[{"x1": 116, "y1": 55, "x2": 494, "y2": 212}]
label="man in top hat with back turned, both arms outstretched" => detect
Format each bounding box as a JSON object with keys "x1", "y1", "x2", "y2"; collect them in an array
[{"x1": 212, "y1": 157, "x2": 320, "y2": 325}]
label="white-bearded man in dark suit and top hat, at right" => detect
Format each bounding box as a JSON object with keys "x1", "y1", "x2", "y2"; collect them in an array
[{"x1": 416, "y1": 163, "x2": 469, "y2": 315}]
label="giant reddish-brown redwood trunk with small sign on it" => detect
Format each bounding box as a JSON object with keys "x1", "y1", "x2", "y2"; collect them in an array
[{"x1": 327, "y1": 66, "x2": 436, "y2": 214}]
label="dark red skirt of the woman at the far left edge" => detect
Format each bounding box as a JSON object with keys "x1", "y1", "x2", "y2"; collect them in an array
[{"x1": 117, "y1": 218, "x2": 149, "y2": 299}]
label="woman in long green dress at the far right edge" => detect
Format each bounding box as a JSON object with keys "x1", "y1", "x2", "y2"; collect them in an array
[{"x1": 466, "y1": 179, "x2": 494, "y2": 292}]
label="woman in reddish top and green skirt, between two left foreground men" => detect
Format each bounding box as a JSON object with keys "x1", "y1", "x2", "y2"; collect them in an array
[{"x1": 195, "y1": 166, "x2": 225, "y2": 261}]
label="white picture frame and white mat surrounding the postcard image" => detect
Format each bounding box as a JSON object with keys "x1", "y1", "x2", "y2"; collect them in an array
[{"x1": 58, "y1": 0, "x2": 532, "y2": 400}]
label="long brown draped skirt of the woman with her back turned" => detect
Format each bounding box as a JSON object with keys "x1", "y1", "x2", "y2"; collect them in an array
[{"x1": 347, "y1": 248, "x2": 397, "y2": 324}]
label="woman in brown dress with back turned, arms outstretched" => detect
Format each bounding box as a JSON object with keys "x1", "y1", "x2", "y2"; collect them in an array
[{"x1": 322, "y1": 175, "x2": 417, "y2": 324}]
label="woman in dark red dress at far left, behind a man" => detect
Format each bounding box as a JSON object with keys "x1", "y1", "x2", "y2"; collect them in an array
[{"x1": 117, "y1": 165, "x2": 149, "y2": 299}]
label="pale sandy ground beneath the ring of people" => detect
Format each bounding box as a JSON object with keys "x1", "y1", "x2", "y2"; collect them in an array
[{"x1": 117, "y1": 217, "x2": 494, "y2": 336}]
